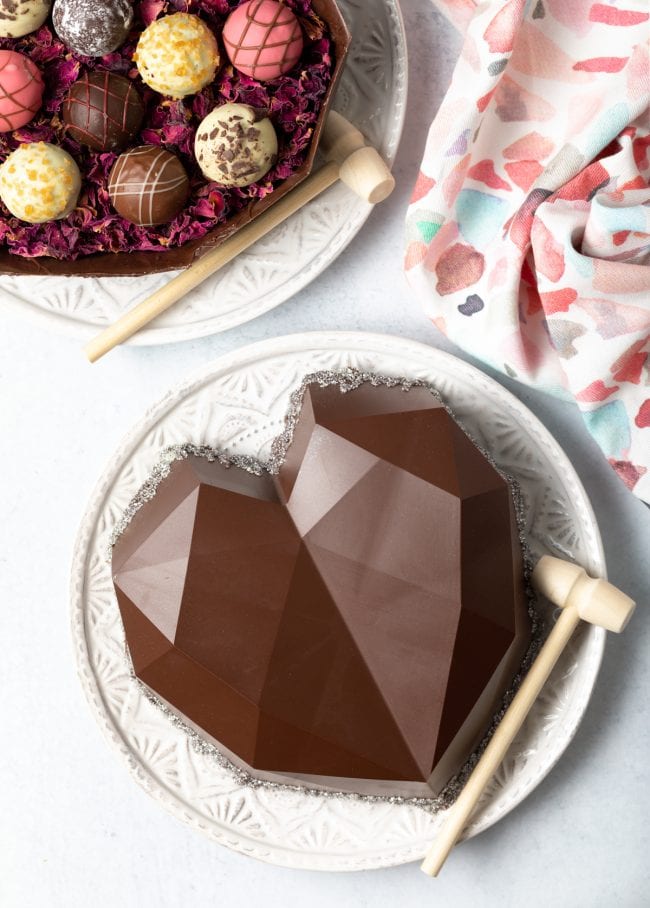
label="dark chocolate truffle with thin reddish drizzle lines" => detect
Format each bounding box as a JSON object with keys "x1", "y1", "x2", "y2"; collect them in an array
[{"x1": 63, "y1": 70, "x2": 144, "y2": 151}]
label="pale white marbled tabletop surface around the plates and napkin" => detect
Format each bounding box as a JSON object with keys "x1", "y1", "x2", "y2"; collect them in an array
[{"x1": 0, "y1": 0, "x2": 650, "y2": 908}]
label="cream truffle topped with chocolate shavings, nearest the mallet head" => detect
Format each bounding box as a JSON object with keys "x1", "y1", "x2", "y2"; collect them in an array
[{"x1": 194, "y1": 104, "x2": 278, "y2": 186}]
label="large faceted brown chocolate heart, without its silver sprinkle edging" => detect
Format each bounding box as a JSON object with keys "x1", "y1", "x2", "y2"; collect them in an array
[{"x1": 113, "y1": 384, "x2": 529, "y2": 794}]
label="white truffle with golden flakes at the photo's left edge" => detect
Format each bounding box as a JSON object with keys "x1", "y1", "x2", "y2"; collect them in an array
[{"x1": 0, "y1": 142, "x2": 81, "y2": 224}]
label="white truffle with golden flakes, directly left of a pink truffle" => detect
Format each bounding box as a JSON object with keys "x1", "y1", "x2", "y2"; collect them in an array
[{"x1": 133, "y1": 13, "x2": 220, "y2": 98}]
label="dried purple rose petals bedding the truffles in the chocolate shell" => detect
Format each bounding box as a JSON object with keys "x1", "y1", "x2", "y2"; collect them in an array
[{"x1": 0, "y1": 0, "x2": 332, "y2": 261}]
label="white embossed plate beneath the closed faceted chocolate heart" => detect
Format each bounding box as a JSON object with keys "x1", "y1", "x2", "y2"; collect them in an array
[{"x1": 72, "y1": 333, "x2": 605, "y2": 870}]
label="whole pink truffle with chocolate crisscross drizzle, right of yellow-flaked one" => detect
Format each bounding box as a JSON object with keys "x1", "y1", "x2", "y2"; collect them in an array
[{"x1": 223, "y1": 0, "x2": 304, "y2": 82}]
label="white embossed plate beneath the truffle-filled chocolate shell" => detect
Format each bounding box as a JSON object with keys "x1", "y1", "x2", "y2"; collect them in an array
[{"x1": 0, "y1": 0, "x2": 407, "y2": 346}]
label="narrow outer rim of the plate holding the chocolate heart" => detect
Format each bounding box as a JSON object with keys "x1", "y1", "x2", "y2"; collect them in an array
[{"x1": 71, "y1": 332, "x2": 606, "y2": 871}]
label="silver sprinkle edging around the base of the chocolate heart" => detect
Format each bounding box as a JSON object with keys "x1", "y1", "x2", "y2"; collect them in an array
[{"x1": 106, "y1": 368, "x2": 548, "y2": 814}]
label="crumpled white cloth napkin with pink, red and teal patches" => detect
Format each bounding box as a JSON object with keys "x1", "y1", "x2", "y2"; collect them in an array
[{"x1": 406, "y1": 0, "x2": 650, "y2": 502}]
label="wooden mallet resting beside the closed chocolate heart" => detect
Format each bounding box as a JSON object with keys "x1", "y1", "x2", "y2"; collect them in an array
[{"x1": 422, "y1": 555, "x2": 635, "y2": 876}]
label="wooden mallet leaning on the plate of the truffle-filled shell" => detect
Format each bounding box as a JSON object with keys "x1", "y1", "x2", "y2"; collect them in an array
[{"x1": 84, "y1": 111, "x2": 395, "y2": 363}]
